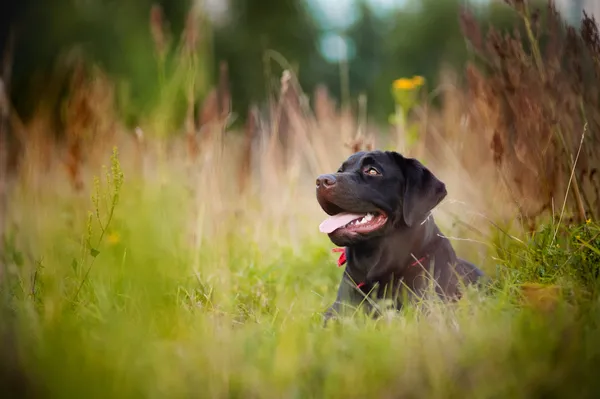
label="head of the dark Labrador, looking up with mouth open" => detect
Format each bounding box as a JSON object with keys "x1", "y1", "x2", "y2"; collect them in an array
[{"x1": 317, "y1": 151, "x2": 447, "y2": 246}]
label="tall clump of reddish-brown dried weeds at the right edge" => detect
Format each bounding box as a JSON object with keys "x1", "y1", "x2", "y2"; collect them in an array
[{"x1": 462, "y1": 1, "x2": 600, "y2": 227}]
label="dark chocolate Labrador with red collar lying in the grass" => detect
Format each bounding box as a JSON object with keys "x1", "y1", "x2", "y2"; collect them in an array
[{"x1": 316, "y1": 151, "x2": 484, "y2": 324}]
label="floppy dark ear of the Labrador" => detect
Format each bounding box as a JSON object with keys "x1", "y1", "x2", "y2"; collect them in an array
[{"x1": 394, "y1": 153, "x2": 448, "y2": 227}]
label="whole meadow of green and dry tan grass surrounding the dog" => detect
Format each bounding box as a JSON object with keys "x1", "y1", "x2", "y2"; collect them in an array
[{"x1": 0, "y1": 2, "x2": 600, "y2": 398}]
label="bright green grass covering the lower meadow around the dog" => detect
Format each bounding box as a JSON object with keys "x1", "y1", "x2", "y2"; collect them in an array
[{"x1": 3, "y1": 148, "x2": 600, "y2": 398}]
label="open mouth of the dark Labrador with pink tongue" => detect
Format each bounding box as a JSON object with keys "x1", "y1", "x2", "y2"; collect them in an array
[{"x1": 319, "y1": 212, "x2": 388, "y2": 234}]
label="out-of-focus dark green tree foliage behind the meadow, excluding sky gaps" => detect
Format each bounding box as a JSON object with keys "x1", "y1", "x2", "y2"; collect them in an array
[{"x1": 4, "y1": 0, "x2": 540, "y2": 130}]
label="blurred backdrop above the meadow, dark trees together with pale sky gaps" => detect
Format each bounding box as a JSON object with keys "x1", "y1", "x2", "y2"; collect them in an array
[{"x1": 0, "y1": 0, "x2": 600, "y2": 126}]
